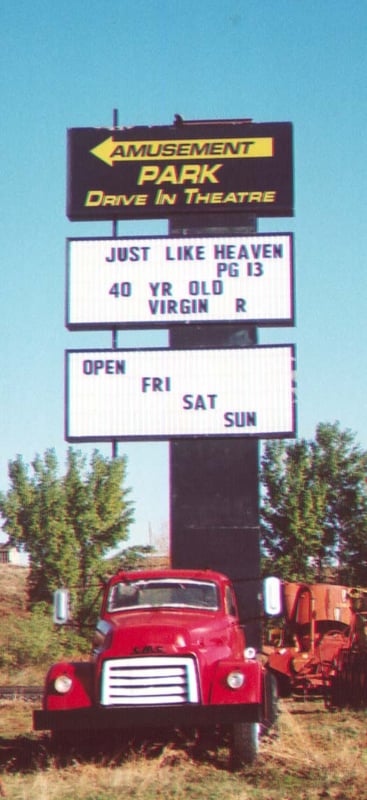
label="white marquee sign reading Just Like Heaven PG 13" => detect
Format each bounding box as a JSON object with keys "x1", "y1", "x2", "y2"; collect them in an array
[{"x1": 66, "y1": 233, "x2": 293, "y2": 330}]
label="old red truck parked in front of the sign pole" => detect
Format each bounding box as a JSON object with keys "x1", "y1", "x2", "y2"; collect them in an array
[{"x1": 33, "y1": 569, "x2": 277, "y2": 767}]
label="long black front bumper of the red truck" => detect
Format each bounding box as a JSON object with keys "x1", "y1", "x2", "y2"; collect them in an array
[{"x1": 33, "y1": 703, "x2": 261, "y2": 731}]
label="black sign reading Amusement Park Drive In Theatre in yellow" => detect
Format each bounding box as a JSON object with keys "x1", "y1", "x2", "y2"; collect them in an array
[{"x1": 67, "y1": 121, "x2": 293, "y2": 220}]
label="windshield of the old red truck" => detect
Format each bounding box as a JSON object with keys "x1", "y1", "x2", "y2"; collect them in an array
[{"x1": 107, "y1": 579, "x2": 219, "y2": 611}]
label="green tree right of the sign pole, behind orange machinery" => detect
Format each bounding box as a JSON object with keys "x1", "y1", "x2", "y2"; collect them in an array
[{"x1": 261, "y1": 423, "x2": 367, "y2": 585}]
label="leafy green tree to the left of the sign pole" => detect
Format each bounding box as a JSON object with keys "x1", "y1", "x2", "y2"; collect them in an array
[{"x1": 0, "y1": 448, "x2": 133, "y2": 622}]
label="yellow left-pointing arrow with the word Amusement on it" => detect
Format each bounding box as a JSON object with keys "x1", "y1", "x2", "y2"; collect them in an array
[{"x1": 90, "y1": 136, "x2": 274, "y2": 167}]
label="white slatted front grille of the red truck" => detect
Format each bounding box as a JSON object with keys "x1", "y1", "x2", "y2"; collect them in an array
[{"x1": 101, "y1": 656, "x2": 199, "y2": 706}]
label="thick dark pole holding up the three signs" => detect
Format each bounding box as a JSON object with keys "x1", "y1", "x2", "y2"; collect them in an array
[{"x1": 169, "y1": 215, "x2": 261, "y2": 648}]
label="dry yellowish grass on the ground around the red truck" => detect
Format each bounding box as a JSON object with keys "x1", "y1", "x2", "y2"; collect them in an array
[{"x1": 0, "y1": 700, "x2": 367, "y2": 800}]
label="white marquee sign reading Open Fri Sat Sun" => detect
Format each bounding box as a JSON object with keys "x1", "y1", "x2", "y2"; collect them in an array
[{"x1": 66, "y1": 345, "x2": 295, "y2": 442}]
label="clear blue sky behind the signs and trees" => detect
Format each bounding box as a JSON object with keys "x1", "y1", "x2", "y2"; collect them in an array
[{"x1": 0, "y1": 0, "x2": 367, "y2": 544}]
